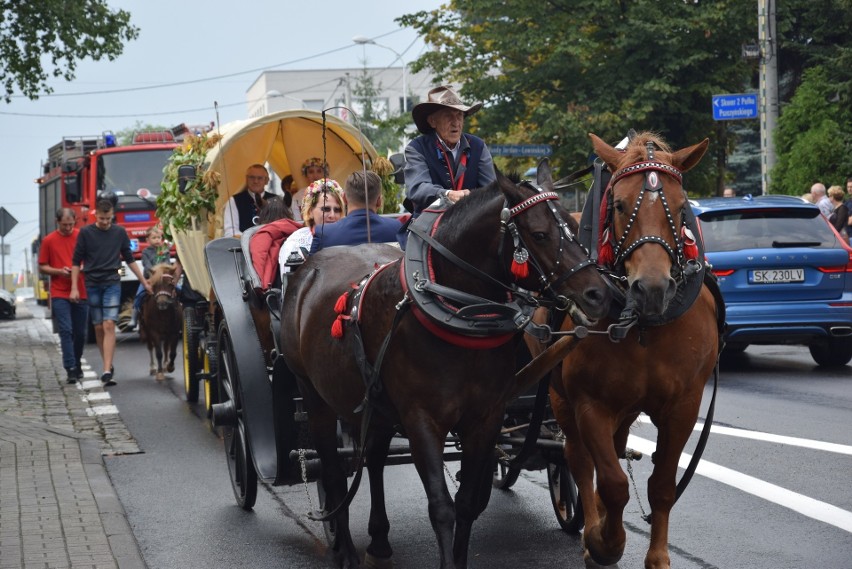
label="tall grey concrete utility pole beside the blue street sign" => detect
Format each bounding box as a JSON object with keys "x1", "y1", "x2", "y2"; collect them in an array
[{"x1": 757, "y1": 0, "x2": 778, "y2": 194}]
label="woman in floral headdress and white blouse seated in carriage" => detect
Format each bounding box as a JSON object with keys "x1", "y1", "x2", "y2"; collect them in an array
[{"x1": 278, "y1": 178, "x2": 346, "y2": 279}]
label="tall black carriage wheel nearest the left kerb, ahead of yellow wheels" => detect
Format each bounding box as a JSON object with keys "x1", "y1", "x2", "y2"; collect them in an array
[{"x1": 217, "y1": 322, "x2": 257, "y2": 510}]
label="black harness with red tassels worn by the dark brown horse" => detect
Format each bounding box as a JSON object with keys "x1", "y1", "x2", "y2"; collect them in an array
[{"x1": 309, "y1": 182, "x2": 594, "y2": 521}]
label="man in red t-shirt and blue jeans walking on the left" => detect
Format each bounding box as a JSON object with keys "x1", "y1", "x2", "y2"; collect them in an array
[{"x1": 38, "y1": 208, "x2": 89, "y2": 383}]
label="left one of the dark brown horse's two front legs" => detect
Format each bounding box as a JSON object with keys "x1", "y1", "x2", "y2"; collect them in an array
[{"x1": 405, "y1": 420, "x2": 456, "y2": 569}]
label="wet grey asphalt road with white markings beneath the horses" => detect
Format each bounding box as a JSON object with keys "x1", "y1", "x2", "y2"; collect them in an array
[{"x1": 93, "y1": 334, "x2": 852, "y2": 569}]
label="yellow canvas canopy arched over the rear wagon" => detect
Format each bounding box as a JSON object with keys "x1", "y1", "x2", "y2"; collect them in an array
[{"x1": 175, "y1": 109, "x2": 376, "y2": 297}]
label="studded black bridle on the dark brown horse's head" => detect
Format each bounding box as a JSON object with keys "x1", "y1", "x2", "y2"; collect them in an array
[{"x1": 498, "y1": 180, "x2": 595, "y2": 309}]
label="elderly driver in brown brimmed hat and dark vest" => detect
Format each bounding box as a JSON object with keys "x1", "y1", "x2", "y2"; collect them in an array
[{"x1": 404, "y1": 85, "x2": 497, "y2": 215}]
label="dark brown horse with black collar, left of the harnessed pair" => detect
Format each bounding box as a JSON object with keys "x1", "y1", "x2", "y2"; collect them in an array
[{"x1": 281, "y1": 169, "x2": 610, "y2": 569}]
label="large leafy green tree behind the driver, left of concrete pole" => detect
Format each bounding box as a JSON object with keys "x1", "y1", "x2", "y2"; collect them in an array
[{"x1": 400, "y1": 0, "x2": 757, "y2": 193}]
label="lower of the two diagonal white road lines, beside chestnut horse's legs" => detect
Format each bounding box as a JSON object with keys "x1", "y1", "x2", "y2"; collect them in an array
[{"x1": 627, "y1": 435, "x2": 852, "y2": 533}]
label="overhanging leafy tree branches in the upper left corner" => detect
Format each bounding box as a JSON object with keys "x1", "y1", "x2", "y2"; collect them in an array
[{"x1": 0, "y1": 0, "x2": 139, "y2": 103}]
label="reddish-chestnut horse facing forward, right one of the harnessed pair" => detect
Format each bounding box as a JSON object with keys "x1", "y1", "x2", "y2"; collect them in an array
[{"x1": 550, "y1": 133, "x2": 724, "y2": 569}]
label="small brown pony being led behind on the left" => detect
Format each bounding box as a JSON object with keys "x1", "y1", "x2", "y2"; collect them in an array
[{"x1": 139, "y1": 263, "x2": 183, "y2": 381}]
